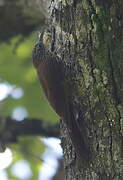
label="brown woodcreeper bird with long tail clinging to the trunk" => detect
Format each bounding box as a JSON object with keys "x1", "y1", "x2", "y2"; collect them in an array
[{"x1": 32, "y1": 31, "x2": 90, "y2": 159}]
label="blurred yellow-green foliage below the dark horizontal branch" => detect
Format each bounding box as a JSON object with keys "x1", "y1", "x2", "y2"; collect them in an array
[{"x1": 7, "y1": 136, "x2": 45, "y2": 180}]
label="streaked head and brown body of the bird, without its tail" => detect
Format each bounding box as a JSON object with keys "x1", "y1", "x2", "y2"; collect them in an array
[{"x1": 33, "y1": 43, "x2": 66, "y2": 118}]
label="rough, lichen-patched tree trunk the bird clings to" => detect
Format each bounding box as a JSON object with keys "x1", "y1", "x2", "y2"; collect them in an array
[{"x1": 46, "y1": 0, "x2": 123, "y2": 180}]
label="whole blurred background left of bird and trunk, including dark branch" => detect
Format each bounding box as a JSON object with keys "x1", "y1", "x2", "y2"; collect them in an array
[{"x1": 0, "y1": 0, "x2": 63, "y2": 180}]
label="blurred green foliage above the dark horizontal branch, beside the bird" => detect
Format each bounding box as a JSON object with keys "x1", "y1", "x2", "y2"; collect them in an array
[{"x1": 0, "y1": 35, "x2": 58, "y2": 121}]
